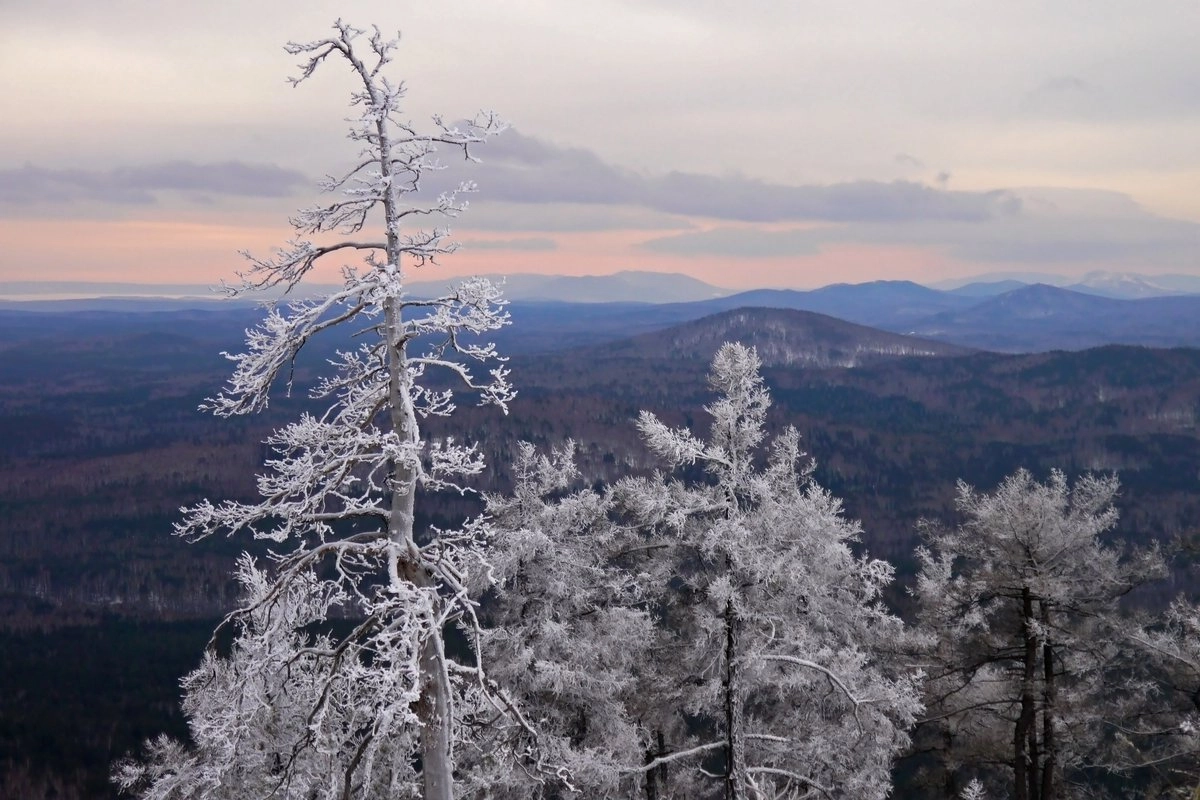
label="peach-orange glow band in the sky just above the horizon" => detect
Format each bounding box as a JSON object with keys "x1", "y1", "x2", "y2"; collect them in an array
[{"x1": 0, "y1": 219, "x2": 1060, "y2": 289}]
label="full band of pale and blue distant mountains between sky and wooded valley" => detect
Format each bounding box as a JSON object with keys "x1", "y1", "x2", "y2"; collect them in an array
[{"x1": 0, "y1": 271, "x2": 1200, "y2": 353}]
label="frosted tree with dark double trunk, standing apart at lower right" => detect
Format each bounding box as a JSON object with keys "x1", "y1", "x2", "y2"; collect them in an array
[{"x1": 916, "y1": 470, "x2": 1163, "y2": 800}]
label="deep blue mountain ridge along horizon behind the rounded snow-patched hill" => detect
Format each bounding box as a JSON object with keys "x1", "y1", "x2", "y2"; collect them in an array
[{"x1": 11, "y1": 272, "x2": 1200, "y2": 353}]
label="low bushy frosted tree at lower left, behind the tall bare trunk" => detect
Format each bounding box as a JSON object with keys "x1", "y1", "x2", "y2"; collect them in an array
[{"x1": 115, "y1": 555, "x2": 412, "y2": 800}]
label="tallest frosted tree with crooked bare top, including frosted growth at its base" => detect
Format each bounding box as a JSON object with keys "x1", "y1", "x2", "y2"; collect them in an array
[{"x1": 113, "y1": 20, "x2": 529, "y2": 800}]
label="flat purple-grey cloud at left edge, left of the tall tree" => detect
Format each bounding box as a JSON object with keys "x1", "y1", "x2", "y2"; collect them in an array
[{"x1": 0, "y1": 161, "x2": 311, "y2": 205}]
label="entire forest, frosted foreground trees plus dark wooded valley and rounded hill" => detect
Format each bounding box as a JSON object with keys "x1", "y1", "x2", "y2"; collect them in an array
[{"x1": 0, "y1": 22, "x2": 1200, "y2": 800}]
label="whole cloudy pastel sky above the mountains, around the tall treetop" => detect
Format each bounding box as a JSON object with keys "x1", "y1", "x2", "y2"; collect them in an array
[{"x1": 0, "y1": 0, "x2": 1200, "y2": 289}]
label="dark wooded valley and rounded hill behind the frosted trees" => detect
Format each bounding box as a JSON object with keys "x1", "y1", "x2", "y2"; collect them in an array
[{"x1": 7, "y1": 304, "x2": 1200, "y2": 796}]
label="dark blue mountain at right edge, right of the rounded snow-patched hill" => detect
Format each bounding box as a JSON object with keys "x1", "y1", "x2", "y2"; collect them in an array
[{"x1": 906, "y1": 283, "x2": 1200, "y2": 353}]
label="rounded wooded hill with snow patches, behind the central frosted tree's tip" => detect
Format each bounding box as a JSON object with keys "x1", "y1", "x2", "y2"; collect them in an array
[{"x1": 596, "y1": 308, "x2": 973, "y2": 367}]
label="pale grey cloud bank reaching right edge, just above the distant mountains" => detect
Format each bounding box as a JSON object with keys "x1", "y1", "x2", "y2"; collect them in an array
[{"x1": 643, "y1": 190, "x2": 1200, "y2": 269}]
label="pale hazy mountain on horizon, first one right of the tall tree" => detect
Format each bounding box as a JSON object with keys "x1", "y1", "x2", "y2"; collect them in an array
[{"x1": 409, "y1": 270, "x2": 730, "y2": 303}]
